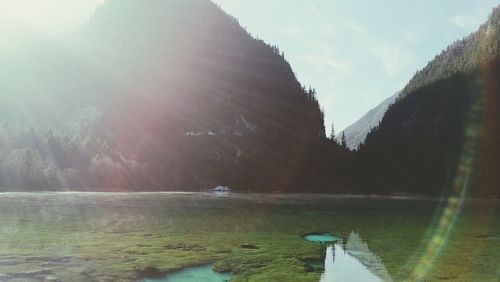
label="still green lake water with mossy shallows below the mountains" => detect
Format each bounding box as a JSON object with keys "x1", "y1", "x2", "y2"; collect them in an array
[{"x1": 0, "y1": 193, "x2": 500, "y2": 281}]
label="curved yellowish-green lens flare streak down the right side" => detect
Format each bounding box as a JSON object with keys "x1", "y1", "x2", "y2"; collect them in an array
[{"x1": 409, "y1": 62, "x2": 500, "y2": 281}]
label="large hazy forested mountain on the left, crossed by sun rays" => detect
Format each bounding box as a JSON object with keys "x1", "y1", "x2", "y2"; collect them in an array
[{"x1": 0, "y1": 0, "x2": 348, "y2": 191}]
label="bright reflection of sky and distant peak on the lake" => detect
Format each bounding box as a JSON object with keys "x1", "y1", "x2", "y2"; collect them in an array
[{"x1": 321, "y1": 232, "x2": 392, "y2": 282}]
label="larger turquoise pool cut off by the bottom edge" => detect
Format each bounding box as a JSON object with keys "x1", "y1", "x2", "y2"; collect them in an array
[{"x1": 142, "y1": 265, "x2": 232, "y2": 282}]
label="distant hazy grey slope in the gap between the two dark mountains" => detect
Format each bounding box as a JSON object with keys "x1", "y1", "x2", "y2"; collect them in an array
[{"x1": 337, "y1": 92, "x2": 401, "y2": 150}]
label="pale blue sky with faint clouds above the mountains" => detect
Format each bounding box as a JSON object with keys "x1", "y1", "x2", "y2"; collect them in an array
[{"x1": 0, "y1": 0, "x2": 500, "y2": 132}]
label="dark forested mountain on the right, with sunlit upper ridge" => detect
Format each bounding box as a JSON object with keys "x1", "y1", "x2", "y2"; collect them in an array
[{"x1": 358, "y1": 8, "x2": 500, "y2": 196}]
